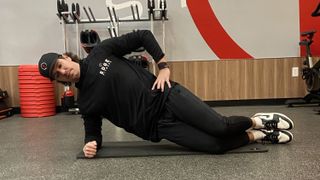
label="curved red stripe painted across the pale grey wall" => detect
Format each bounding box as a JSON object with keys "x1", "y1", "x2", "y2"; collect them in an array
[{"x1": 187, "y1": 0, "x2": 252, "y2": 59}]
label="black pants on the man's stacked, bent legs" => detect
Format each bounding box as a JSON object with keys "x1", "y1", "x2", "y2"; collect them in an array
[{"x1": 158, "y1": 85, "x2": 252, "y2": 154}]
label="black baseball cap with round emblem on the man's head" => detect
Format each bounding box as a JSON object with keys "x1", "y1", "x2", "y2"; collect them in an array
[{"x1": 38, "y1": 53, "x2": 62, "y2": 80}]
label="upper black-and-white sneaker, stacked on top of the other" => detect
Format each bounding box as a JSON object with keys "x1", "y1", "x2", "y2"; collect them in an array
[{"x1": 252, "y1": 113, "x2": 294, "y2": 130}]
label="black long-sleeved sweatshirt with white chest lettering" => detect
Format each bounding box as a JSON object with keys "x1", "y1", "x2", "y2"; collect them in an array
[{"x1": 76, "y1": 30, "x2": 175, "y2": 148}]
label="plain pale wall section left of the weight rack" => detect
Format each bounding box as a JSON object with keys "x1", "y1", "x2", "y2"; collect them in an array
[{"x1": 0, "y1": 0, "x2": 61, "y2": 65}]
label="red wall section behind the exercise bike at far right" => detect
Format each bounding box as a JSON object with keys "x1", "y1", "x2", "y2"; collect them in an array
[{"x1": 299, "y1": 0, "x2": 320, "y2": 56}]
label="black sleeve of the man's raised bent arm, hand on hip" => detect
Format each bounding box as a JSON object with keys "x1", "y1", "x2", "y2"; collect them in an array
[{"x1": 99, "y1": 30, "x2": 164, "y2": 62}]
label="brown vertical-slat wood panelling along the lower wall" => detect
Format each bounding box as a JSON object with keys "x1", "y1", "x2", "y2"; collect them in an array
[{"x1": 0, "y1": 58, "x2": 306, "y2": 107}]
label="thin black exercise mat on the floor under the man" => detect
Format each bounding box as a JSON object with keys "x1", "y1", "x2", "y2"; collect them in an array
[{"x1": 77, "y1": 141, "x2": 268, "y2": 159}]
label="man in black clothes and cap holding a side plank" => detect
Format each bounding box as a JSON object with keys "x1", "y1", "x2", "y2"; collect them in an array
[{"x1": 39, "y1": 30, "x2": 294, "y2": 158}]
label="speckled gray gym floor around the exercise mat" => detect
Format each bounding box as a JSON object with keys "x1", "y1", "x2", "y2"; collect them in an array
[{"x1": 0, "y1": 106, "x2": 320, "y2": 180}]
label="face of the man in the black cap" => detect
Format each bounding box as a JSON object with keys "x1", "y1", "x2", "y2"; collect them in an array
[{"x1": 52, "y1": 56, "x2": 80, "y2": 82}]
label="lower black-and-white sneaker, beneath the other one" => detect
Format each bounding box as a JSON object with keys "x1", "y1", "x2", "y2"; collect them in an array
[{"x1": 258, "y1": 129, "x2": 293, "y2": 144}]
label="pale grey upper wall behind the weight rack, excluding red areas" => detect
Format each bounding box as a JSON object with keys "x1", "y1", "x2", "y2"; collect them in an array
[{"x1": 0, "y1": 0, "x2": 299, "y2": 66}]
